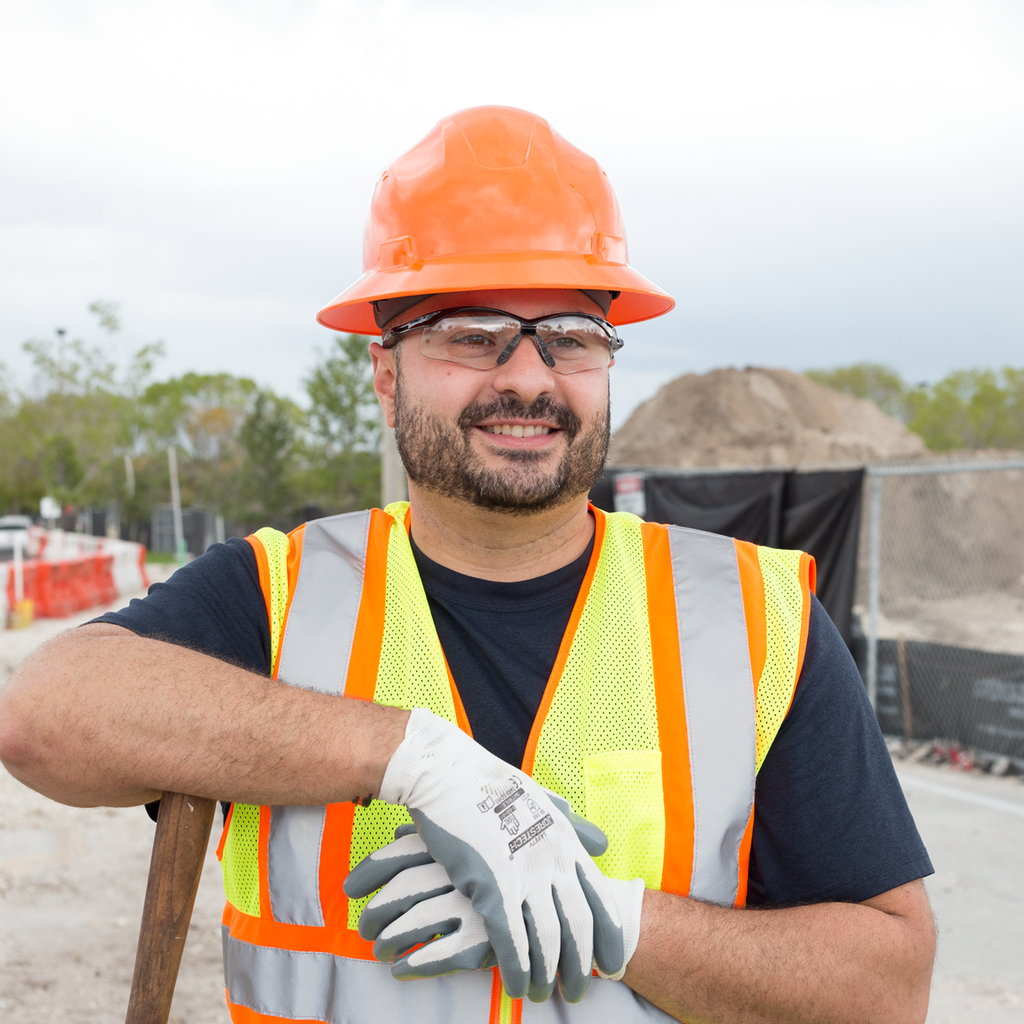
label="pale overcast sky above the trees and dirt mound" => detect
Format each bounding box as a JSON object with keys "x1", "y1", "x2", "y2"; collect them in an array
[{"x1": 0, "y1": 0, "x2": 1024, "y2": 423}]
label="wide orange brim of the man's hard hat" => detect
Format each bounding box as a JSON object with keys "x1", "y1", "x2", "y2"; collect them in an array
[{"x1": 316, "y1": 253, "x2": 676, "y2": 335}]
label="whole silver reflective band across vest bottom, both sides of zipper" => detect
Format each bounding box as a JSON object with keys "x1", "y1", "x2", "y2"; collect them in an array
[{"x1": 221, "y1": 926, "x2": 673, "y2": 1024}]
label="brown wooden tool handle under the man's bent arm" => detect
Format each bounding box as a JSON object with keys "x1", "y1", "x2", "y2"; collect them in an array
[{"x1": 125, "y1": 793, "x2": 217, "y2": 1024}]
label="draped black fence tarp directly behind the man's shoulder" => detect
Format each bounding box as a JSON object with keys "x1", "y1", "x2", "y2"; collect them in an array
[{"x1": 590, "y1": 467, "x2": 864, "y2": 644}]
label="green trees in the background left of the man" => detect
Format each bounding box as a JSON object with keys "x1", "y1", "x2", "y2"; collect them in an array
[{"x1": 0, "y1": 301, "x2": 380, "y2": 528}]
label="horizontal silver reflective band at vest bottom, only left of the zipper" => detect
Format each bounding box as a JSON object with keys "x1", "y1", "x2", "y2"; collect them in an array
[{"x1": 221, "y1": 927, "x2": 492, "y2": 1024}]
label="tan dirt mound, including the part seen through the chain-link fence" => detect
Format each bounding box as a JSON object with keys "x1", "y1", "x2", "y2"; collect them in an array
[{"x1": 608, "y1": 367, "x2": 1024, "y2": 654}]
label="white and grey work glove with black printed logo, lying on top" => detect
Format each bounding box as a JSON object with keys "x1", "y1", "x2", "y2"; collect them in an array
[{"x1": 344, "y1": 708, "x2": 623, "y2": 1001}]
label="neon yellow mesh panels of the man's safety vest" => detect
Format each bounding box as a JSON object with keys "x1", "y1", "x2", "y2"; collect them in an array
[{"x1": 222, "y1": 516, "x2": 803, "y2": 929}]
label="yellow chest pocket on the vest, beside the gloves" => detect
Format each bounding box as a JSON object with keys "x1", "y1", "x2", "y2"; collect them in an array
[{"x1": 583, "y1": 751, "x2": 665, "y2": 889}]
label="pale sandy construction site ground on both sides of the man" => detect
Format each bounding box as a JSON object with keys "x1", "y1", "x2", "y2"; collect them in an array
[{"x1": 0, "y1": 581, "x2": 1024, "y2": 1024}]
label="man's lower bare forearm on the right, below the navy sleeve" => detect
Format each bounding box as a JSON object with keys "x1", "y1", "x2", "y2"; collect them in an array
[{"x1": 625, "y1": 882, "x2": 935, "y2": 1024}]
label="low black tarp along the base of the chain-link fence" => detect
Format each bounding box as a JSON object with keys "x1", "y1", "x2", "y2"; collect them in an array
[{"x1": 856, "y1": 640, "x2": 1024, "y2": 760}]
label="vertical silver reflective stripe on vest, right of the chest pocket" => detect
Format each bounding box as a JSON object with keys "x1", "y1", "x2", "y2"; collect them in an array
[{"x1": 669, "y1": 526, "x2": 756, "y2": 903}]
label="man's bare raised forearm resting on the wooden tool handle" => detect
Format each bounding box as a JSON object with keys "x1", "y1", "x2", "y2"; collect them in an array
[{"x1": 0, "y1": 626, "x2": 408, "y2": 806}]
